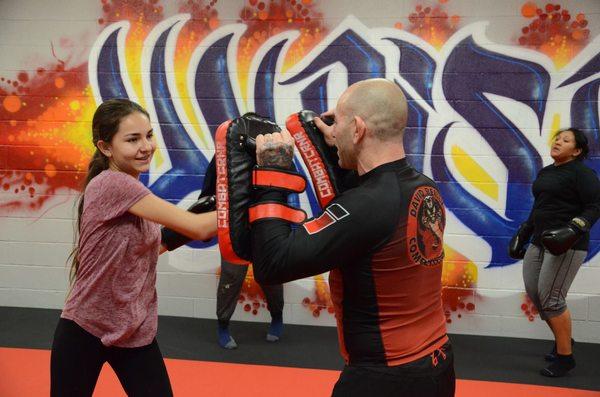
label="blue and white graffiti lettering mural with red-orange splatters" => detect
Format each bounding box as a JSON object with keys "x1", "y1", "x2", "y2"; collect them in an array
[{"x1": 0, "y1": 0, "x2": 600, "y2": 322}]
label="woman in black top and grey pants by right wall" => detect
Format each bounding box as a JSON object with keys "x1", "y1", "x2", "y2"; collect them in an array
[{"x1": 509, "y1": 128, "x2": 600, "y2": 377}]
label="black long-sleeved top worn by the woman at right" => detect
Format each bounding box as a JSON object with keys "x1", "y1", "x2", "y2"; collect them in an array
[{"x1": 529, "y1": 160, "x2": 600, "y2": 251}]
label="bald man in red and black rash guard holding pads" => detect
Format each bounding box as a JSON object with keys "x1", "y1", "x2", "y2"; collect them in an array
[{"x1": 251, "y1": 79, "x2": 455, "y2": 397}]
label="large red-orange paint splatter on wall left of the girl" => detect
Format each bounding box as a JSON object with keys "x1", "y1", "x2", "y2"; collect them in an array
[{"x1": 0, "y1": 61, "x2": 95, "y2": 210}]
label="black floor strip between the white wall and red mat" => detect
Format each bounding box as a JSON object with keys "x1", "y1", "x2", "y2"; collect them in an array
[{"x1": 0, "y1": 307, "x2": 600, "y2": 390}]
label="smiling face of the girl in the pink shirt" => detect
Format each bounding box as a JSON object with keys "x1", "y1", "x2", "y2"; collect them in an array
[{"x1": 98, "y1": 112, "x2": 156, "y2": 178}]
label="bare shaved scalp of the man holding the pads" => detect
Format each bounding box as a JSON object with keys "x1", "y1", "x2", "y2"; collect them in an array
[{"x1": 340, "y1": 79, "x2": 407, "y2": 141}]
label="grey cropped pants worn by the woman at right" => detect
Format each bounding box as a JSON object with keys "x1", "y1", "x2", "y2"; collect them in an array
[{"x1": 523, "y1": 244, "x2": 587, "y2": 320}]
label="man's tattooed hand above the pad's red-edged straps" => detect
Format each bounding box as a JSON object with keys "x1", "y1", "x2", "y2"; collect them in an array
[{"x1": 256, "y1": 130, "x2": 294, "y2": 169}]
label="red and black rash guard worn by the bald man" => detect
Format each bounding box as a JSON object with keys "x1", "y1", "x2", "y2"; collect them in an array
[{"x1": 251, "y1": 159, "x2": 448, "y2": 366}]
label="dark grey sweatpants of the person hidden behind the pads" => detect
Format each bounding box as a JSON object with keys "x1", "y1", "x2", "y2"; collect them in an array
[{"x1": 217, "y1": 259, "x2": 283, "y2": 327}]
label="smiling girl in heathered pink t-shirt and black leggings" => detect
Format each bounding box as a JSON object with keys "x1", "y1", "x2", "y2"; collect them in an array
[{"x1": 51, "y1": 99, "x2": 217, "y2": 396}]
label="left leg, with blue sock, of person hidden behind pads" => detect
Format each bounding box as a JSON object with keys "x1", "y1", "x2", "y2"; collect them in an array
[{"x1": 217, "y1": 259, "x2": 248, "y2": 349}]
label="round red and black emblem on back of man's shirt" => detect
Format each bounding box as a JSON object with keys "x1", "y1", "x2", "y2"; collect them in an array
[{"x1": 406, "y1": 186, "x2": 446, "y2": 266}]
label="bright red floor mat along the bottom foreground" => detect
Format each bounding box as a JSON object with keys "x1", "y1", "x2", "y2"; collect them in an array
[{"x1": 0, "y1": 348, "x2": 600, "y2": 397}]
